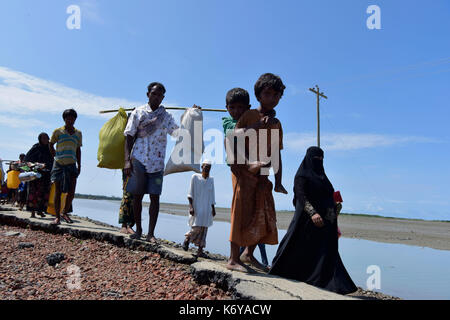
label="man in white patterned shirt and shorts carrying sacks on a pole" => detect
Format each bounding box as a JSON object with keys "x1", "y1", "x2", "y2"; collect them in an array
[{"x1": 124, "y1": 82, "x2": 199, "y2": 242}]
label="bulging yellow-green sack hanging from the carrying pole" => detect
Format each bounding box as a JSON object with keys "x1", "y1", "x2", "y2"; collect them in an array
[{"x1": 97, "y1": 108, "x2": 127, "y2": 169}]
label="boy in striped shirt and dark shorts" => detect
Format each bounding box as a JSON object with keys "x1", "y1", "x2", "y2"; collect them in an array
[{"x1": 49, "y1": 109, "x2": 82, "y2": 224}]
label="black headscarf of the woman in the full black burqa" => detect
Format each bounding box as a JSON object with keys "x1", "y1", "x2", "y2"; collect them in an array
[{"x1": 294, "y1": 147, "x2": 334, "y2": 209}]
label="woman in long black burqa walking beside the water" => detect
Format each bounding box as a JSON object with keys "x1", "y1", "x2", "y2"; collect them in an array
[{"x1": 269, "y1": 147, "x2": 357, "y2": 294}]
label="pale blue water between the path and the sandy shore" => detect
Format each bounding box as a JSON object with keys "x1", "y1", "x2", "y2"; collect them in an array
[{"x1": 74, "y1": 199, "x2": 450, "y2": 299}]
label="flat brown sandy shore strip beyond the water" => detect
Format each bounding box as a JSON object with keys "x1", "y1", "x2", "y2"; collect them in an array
[{"x1": 160, "y1": 203, "x2": 450, "y2": 250}]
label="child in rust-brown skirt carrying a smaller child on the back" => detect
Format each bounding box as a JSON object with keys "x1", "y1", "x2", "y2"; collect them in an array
[{"x1": 227, "y1": 73, "x2": 287, "y2": 271}]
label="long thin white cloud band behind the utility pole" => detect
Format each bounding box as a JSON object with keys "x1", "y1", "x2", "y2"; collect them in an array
[{"x1": 284, "y1": 133, "x2": 438, "y2": 151}]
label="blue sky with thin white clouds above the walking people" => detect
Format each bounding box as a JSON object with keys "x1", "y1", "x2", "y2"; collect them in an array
[{"x1": 0, "y1": 0, "x2": 450, "y2": 220}]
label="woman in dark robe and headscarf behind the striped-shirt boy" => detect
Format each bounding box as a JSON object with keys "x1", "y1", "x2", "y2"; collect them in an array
[{"x1": 25, "y1": 132, "x2": 53, "y2": 218}]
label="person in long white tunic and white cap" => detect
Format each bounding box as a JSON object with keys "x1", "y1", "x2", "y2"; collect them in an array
[{"x1": 183, "y1": 160, "x2": 216, "y2": 257}]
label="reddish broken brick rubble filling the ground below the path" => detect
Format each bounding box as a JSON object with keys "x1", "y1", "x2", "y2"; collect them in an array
[{"x1": 0, "y1": 225, "x2": 231, "y2": 300}]
